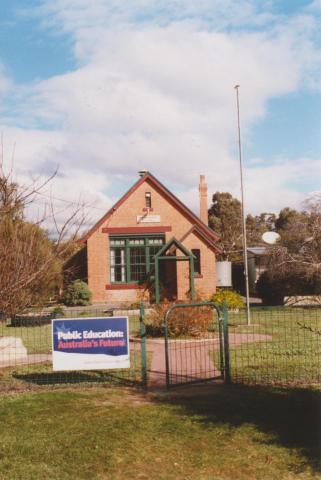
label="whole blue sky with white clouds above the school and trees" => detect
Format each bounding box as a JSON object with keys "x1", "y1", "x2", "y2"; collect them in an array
[{"x1": 0, "y1": 0, "x2": 321, "y2": 229}]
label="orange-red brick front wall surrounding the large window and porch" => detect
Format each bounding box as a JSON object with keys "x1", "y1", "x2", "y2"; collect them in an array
[{"x1": 87, "y1": 181, "x2": 216, "y2": 302}]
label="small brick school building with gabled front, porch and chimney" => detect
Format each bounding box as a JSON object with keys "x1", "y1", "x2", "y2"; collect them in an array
[{"x1": 84, "y1": 171, "x2": 220, "y2": 302}]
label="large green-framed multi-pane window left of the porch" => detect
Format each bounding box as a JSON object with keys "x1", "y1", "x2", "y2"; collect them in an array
[{"x1": 110, "y1": 235, "x2": 164, "y2": 283}]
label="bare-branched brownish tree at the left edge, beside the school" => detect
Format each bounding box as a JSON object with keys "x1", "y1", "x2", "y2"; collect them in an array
[{"x1": 0, "y1": 161, "x2": 84, "y2": 316}]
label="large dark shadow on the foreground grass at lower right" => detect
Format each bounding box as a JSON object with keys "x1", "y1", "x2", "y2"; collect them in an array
[{"x1": 159, "y1": 385, "x2": 321, "y2": 471}]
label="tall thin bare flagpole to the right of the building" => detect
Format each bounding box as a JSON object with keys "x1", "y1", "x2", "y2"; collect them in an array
[{"x1": 234, "y1": 85, "x2": 251, "y2": 325}]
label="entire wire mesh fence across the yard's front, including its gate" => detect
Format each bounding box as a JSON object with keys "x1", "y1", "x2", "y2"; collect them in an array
[{"x1": 0, "y1": 305, "x2": 321, "y2": 390}]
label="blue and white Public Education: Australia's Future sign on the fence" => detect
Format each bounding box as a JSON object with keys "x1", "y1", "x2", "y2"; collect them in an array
[{"x1": 52, "y1": 317, "x2": 130, "y2": 371}]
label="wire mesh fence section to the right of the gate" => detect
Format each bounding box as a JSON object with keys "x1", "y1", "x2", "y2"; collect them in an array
[{"x1": 228, "y1": 307, "x2": 321, "y2": 385}]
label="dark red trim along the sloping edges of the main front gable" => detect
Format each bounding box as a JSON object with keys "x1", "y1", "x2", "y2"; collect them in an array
[{"x1": 82, "y1": 172, "x2": 220, "y2": 251}]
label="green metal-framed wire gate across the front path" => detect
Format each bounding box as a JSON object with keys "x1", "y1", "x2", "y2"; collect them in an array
[{"x1": 164, "y1": 302, "x2": 229, "y2": 388}]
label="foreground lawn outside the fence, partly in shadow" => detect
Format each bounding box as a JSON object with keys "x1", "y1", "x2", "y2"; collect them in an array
[{"x1": 0, "y1": 386, "x2": 321, "y2": 480}]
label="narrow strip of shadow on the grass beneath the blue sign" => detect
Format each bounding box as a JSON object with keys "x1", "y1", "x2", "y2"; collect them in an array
[{"x1": 12, "y1": 371, "x2": 140, "y2": 386}]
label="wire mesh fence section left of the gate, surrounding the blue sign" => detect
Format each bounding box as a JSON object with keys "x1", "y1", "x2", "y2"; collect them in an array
[{"x1": 0, "y1": 307, "x2": 145, "y2": 386}]
